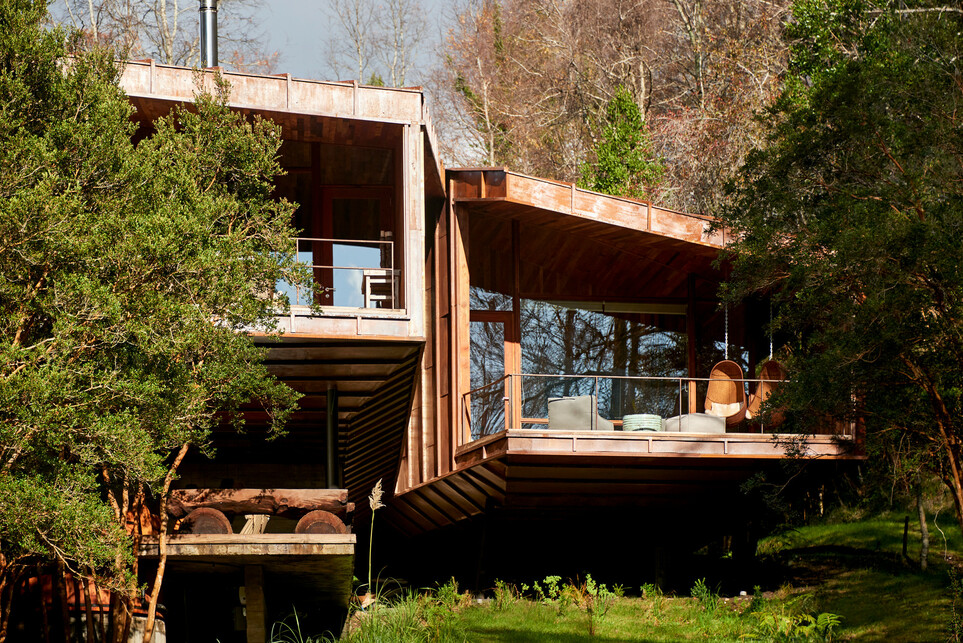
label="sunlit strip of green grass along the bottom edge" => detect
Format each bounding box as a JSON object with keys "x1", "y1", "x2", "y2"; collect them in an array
[{"x1": 345, "y1": 583, "x2": 844, "y2": 643}]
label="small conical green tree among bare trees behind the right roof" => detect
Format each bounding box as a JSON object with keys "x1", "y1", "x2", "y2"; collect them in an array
[{"x1": 579, "y1": 86, "x2": 664, "y2": 199}]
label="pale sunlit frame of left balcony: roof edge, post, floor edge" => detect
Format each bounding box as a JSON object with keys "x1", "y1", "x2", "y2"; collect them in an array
[{"x1": 120, "y1": 60, "x2": 445, "y2": 348}]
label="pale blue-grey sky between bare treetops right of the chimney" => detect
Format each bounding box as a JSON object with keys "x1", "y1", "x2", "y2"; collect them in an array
[{"x1": 257, "y1": 0, "x2": 451, "y2": 80}]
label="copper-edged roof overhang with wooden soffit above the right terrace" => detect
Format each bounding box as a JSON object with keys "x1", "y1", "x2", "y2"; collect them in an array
[{"x1": 448, "y1": 168, "x2": 727, "y2": 305}]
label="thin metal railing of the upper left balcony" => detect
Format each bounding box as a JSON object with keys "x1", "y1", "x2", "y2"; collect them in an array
[{"x1": 277, "y1": 237, "x2": 400, "y2": 308}]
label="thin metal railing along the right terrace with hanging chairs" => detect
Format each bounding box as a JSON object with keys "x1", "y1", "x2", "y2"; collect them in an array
[{"x1": 462, "y1": 373, "x2": 855, "y2": 444}]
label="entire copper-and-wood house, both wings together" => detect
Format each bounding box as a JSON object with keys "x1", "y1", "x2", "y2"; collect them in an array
[{"x1": 103, "y1": 61, "x2": 860, "y2": 641}]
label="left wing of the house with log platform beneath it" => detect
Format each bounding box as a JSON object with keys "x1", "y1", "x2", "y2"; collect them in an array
[{"x1": 115, "y1": 60, "x2": 445, "y2": 641}]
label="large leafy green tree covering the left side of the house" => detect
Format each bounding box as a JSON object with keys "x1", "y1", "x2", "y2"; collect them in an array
[{"x1": 0, "y1": 0, "x2": 296, "y2": 641}]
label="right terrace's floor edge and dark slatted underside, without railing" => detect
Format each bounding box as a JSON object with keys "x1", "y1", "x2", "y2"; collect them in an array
[{"x1": 386, "y1": 429, "x2": 862, "y2": 534}]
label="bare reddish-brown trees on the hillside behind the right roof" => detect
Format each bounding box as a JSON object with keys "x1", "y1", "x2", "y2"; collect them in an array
[{"x1": 444, "y1": 0, "x2": 788, "y2": 212}]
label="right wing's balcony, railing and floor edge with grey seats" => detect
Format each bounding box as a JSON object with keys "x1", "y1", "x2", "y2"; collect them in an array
[{"x1": 456, "y1": 373, "x2": 856, "y2": 464}]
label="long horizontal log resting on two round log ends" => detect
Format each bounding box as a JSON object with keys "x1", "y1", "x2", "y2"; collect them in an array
[{"x1": 167, "y1": 489, "x2": 354, "y2": 518}]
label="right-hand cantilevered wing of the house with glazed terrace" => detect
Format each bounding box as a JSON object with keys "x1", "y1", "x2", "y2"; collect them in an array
[{"x1": 386, "y1": 168, "x2": 861, "y2": 533}]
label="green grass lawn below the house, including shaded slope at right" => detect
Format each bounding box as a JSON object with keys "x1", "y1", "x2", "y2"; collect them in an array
[{"x1": 334, "y1": 515, "x2": 963, "y2": 643}]
